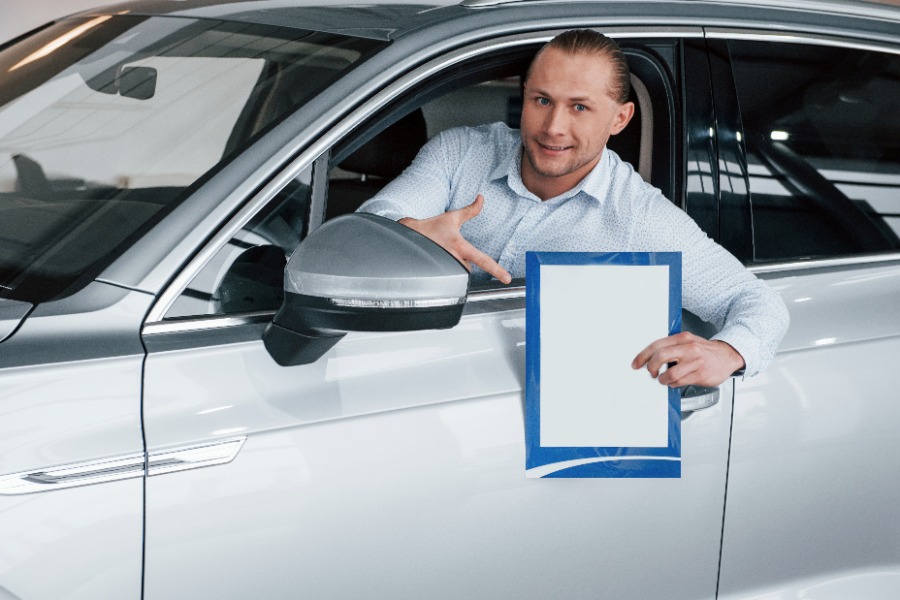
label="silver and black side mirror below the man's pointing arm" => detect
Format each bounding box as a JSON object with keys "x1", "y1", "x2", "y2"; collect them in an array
[{"x1": 263, "y1": 213, "x2": 469, "y2": 366}]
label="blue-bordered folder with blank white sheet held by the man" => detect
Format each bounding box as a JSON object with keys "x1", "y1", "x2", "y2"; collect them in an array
[{"x1": 525, "y1": 252, "x2": 681, "y2": 478}]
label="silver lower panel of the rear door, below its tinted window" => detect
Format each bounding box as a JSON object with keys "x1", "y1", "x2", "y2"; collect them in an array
[{"x1": 720, "y1": 265, "x2": 900, "y2": 599}]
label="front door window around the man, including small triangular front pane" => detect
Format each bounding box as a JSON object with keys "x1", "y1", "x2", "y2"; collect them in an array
[{"x1": 164, "y1": 39, "x2": 684, "y2": 319}]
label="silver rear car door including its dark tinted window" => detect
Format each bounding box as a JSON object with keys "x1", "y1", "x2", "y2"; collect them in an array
[{"x1": 710, "y1": 30, "x2": 900, "y2": 598}]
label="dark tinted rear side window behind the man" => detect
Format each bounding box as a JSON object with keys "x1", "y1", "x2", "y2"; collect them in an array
[{"x1": 729, "y1": 41, "x2": 900, "y2": 262}]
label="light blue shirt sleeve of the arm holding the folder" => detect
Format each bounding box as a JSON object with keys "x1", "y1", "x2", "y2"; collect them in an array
[{"x1": 638, "y1": 190, "x2": 789, "y2": 377}]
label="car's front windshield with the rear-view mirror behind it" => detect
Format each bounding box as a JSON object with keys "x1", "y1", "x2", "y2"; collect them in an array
[{"x1": 0, "y1": 15, "x2": 383, "y2": 302}]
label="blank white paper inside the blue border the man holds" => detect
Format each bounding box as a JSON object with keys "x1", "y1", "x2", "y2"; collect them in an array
[{"x1": 540, "y1": 265, "x2": 669, "y2": 448}]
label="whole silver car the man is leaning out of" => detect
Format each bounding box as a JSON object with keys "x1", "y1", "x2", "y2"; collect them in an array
[{"x1": 0, "y1": 0, "x2": 900, "y2": 600}]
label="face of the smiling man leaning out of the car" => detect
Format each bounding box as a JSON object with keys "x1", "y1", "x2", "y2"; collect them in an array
[{"x1": 521, "y1": 48, "x2": 634, "y2": 199}]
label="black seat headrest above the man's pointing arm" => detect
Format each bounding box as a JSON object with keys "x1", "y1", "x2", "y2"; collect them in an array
[{"x1": 340, "y1": 110, "x2": 428, "y2": 179}]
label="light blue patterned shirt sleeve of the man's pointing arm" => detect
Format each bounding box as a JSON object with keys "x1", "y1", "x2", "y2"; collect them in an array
[{"x1": 357, "y1": 130, "x2": 461, "y2": 221}]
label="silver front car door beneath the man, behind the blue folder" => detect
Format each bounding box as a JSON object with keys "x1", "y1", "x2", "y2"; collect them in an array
[{"x1": 143, "y1": 31, "x2": 733, "y2": 599}]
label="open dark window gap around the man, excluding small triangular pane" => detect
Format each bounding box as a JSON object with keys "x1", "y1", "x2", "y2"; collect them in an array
[{"x1": 326, "y1": 41, "x2": 674, "y2": 289}]
